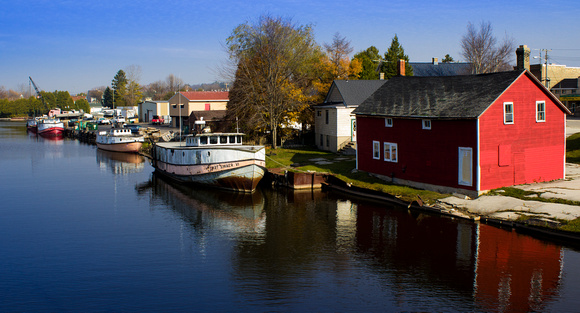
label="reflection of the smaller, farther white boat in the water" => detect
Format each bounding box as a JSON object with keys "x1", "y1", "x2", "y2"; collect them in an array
[{"x1": 96, "y1": 149, "x2": 145, "y2": 175}]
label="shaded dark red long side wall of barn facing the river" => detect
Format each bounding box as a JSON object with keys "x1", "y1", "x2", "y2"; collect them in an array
[{"x1": 357, "y1": 116, "x2": 476, "y2": 190}]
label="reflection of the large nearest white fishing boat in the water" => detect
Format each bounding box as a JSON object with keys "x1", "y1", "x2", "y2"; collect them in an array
[{"x1": 151, "y1": 173, "x2": 265, "y2": 233}]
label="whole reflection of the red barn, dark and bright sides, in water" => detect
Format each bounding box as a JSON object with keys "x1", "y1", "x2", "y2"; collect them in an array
[{"x1": 357, "y1": 201, "x2": 563, "y2": 312}]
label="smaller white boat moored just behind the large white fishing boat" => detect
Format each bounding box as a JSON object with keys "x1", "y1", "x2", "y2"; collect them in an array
[{"x1": 96, "y1": 128, "x2": 145, "y2": 153}]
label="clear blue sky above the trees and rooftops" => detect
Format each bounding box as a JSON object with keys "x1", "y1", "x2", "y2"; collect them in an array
[{"x1": 0, "y1": 0, "x2": 580, "y2": 94}]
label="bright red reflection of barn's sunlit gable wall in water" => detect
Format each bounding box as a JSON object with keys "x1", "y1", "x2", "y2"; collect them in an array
[{"x1": 474, "y1": 225, "x2": 563, "y2": 312}]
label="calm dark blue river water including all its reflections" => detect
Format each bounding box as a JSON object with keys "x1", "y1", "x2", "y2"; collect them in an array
[{"x1": 0, "y1": 122, "x2": 580, "y2": 312}]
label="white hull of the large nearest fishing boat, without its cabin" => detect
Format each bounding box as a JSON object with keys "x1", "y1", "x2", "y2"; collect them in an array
[{"x1": 153, "y1": 143, "x2": 266, "y2": 192}]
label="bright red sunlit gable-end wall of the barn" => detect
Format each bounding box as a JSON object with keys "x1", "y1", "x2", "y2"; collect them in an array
[{"x1": 479, "y1": 75, "x2": 565, "y2": 190}]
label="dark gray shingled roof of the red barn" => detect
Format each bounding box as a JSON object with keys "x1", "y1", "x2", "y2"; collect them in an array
[{"x1": 353, "y1": 71, "x2": 523, "y2": 118}]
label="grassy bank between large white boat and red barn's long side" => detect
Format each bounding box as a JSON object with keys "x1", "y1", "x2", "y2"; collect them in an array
[{"x1": 266, "y1": 148, "x2": 449, "y2": 203}]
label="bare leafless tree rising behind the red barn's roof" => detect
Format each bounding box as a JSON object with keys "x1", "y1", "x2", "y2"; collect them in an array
[{"x1": 461, "y1": 22, "x2": 515, "y2": 74}]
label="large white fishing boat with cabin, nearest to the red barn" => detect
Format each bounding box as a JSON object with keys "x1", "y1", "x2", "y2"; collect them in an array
[{"x1": 151, "y1": 133, "x2": 266, "y2": 192}]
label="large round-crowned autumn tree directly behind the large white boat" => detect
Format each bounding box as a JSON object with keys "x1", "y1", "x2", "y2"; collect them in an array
[{"x1": 226, "y1": 16, "x2": 322, "y2": 148}]
